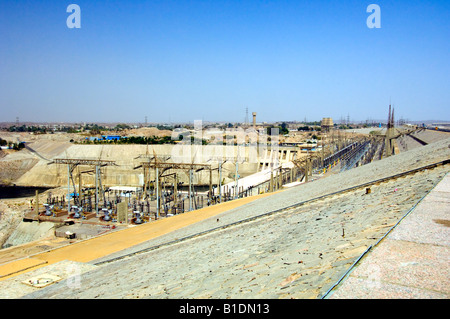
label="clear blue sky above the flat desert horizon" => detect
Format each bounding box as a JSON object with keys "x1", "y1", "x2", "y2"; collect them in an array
[{"x1": 0, "y1": 0, "x2": 450, "y2": 122}]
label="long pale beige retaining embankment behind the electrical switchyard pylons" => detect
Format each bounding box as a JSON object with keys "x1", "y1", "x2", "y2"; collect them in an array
[{"x1": 11, "y1": 145, "x2": 295, "y2": 187}]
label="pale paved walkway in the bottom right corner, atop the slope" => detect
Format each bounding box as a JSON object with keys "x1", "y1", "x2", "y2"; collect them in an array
[{"x1": 329, "y1": 174, "x2": 450, "y2": 299}]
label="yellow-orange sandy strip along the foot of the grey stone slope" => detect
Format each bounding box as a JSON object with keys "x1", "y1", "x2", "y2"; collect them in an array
[{"x1": 0, "y1": 193, "x2": 274, "y2": 281}]
